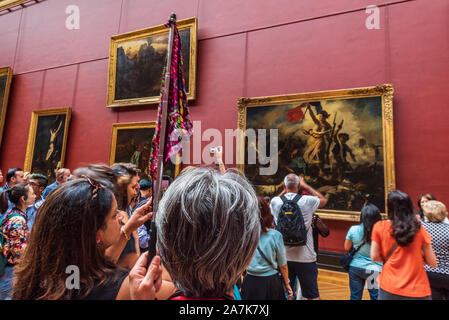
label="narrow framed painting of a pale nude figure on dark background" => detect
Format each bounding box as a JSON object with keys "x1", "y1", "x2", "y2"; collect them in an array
[{"x1": 24, "y1": 108, "x2": 71, "y2": 181}]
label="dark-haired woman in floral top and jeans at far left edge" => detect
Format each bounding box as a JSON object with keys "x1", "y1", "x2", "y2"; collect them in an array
[{"x1": 0, "y1": 183, "x2": 36, "y2": 300}]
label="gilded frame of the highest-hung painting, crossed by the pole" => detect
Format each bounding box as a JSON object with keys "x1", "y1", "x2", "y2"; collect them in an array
[{"x1": 106, "y1": 18, "x2": 198, "y2": 108}]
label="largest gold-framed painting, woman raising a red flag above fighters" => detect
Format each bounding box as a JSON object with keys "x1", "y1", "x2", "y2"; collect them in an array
[{"x1": 238, "y1": 84, "x2": 395, "y2": 221}]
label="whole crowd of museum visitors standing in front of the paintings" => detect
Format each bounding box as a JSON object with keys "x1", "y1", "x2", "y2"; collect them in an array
[{"x1": 0, "y1": 162, "x2": 449, "y2": 300}]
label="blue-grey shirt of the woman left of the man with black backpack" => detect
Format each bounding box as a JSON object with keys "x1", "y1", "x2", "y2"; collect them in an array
[{"x1": 246, "y1": 229, "x2": 287, "y2": 277}]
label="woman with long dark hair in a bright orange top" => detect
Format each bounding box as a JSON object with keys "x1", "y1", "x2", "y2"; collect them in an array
[{"x1": 371, "y1": 190, "x2": 437, "y2": 300}]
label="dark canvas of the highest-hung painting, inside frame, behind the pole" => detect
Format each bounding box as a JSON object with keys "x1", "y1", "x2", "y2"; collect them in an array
[{"x1": 114, "y1": 28, "x2": 191, "y2": 100}]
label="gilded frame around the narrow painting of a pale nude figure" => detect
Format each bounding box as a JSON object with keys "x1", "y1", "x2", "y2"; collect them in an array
[{"x1": 23, "y1": 108, "x2": 72, "y2": 172}]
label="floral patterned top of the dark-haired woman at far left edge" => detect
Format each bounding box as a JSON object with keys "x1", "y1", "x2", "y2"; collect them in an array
[{"x1": 1, "y1": 208, "x2": 29, "y2": 265}]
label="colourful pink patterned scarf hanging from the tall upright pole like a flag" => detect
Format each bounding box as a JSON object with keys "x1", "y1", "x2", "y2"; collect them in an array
[{"x1": 148, "y1": 17, "x2": 193, "y2": 180}]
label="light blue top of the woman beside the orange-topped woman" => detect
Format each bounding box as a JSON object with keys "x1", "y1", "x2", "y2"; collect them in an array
[{"x1": 346, "y1": 223, "x2": 382, "y2": 272}]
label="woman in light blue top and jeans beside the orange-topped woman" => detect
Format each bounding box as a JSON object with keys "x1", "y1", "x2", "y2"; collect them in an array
[{"x1": 345, "y1": 204, "x2": 382, "y2": 300}]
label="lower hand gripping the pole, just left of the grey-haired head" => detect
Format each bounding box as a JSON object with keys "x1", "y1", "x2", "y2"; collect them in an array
[{"x1": 129, "y1": 252, "x2": 162, "y2": 300}]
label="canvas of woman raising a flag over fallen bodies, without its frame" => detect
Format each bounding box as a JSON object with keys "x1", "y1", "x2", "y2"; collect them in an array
[{"x1": 244, "y1": 96, "x2": 385, "y2": 212}]
